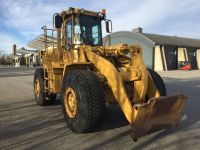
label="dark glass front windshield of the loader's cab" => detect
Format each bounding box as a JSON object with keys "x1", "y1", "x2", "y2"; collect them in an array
[{"x1": 74, "y1": 15, "x2": 102, "y2": 46}]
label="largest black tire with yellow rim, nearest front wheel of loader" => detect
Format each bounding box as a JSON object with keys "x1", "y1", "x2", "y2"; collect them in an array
[{"x1": 61, "y1": 70, "x2": 105, "y2": 133}]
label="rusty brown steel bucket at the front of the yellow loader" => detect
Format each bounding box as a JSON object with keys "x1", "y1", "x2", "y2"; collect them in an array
[{"x1": 131, "y1": 95, "x2": 186, "y2": 141}]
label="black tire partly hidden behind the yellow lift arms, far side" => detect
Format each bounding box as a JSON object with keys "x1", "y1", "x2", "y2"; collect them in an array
[{"x1": 147, "y1": 68, "x2": 167, "y2": 96}]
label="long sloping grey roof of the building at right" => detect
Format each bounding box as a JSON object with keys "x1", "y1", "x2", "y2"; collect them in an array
[{"x1": 140, "y1": 33, "x2": 200, "y2": 48}]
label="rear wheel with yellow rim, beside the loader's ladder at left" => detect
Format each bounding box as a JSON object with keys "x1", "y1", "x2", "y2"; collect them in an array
[{"x1": 34, "y1": 68, "x2": 56, "y2": 106}]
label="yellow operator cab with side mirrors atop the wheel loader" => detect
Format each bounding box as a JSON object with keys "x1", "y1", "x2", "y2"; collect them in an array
[{"x1": 54, "y1": 8, "x2": 112, "y2": 49}]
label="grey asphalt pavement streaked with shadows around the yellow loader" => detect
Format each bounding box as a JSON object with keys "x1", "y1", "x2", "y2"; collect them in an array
[{"x1": 0, "y1": 72, "x2": 200, "y2": 150}]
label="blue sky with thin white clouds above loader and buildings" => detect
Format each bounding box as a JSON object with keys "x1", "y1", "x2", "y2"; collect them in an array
[{"x1": 0, "y1": 0, "x2": 200, "y2": 54}]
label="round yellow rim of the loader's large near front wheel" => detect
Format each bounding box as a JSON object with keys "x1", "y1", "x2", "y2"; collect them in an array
[{"x1": 64, "y1": 87, "x2": 77, "y2": 118}]
